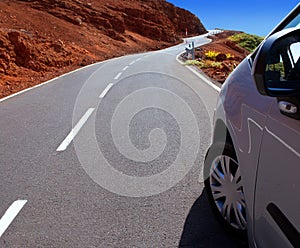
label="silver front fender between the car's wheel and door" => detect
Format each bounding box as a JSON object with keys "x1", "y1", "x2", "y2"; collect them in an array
[{"x1": 215, "y1": 59, "x2": 275, "y2": 246}]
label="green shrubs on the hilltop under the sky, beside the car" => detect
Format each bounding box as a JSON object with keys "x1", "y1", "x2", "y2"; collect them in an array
[{"x1": 228, "y1": 33, "x2": 264, "y2": 52}]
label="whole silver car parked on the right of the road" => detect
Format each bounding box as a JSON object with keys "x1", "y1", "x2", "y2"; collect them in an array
[{"x1": 204, "y1": 4, "x2": 300, "y2": 248}]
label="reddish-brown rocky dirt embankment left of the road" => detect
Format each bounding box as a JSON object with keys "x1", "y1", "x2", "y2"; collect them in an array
[{"x1": 0, "y1": 0, "x2": 206, "y2": 98}]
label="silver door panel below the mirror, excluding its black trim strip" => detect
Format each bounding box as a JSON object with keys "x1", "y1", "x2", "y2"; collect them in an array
[{"x1": 255, "y1": 102, "x2": 300, "y2": 247}]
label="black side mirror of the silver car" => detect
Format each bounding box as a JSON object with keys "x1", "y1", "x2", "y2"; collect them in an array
[{"x1": 252, "y1": 28, "x2": 300, "y2": 97}]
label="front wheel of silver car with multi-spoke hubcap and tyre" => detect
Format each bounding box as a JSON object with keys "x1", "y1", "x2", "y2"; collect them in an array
[{"x1": 204, "y1": 143, "x2": 247, "y2": 235}]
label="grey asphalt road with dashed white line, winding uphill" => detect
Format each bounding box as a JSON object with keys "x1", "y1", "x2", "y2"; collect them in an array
[{"x1": 0, "y1": 34, "x2": 246, "y2": 247}]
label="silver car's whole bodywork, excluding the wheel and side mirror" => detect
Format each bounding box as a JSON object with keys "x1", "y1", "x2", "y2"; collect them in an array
[{"x1": 206, "y1": 4, "x2": 300, "y2": 247}]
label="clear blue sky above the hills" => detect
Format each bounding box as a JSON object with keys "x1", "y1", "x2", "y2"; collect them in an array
[{"x1": 167, "y1": 0, "x2": 299, "y2": 36}]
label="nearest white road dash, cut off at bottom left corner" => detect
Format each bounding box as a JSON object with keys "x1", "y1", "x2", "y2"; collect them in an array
[{"x1": 0, "y1": 200, "x2": 27, "y2": 238}]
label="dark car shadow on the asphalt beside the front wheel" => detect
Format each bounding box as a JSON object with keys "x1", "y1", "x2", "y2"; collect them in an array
[{"x1": 179, "y1": 190, "x2": 248, "y2": 248}]
